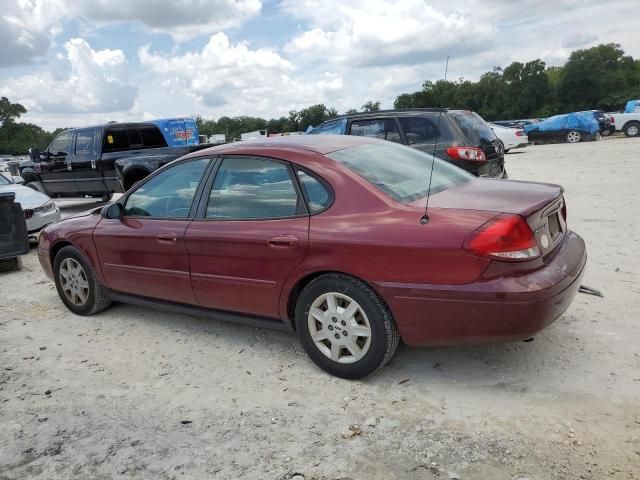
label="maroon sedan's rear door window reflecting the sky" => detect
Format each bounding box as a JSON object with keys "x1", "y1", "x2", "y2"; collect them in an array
[{"x1": 206, "y1": 157, "x2": 302, "y2": 219}]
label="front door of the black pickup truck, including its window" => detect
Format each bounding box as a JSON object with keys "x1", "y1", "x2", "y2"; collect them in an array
[{"x1": 38, "y1": 130, "x2": 76, "y2": 194}]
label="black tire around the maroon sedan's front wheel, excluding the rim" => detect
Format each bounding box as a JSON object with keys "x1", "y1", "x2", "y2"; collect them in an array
[{"x1": 53, "y1": 246, "x2": 111, "y2": 315}]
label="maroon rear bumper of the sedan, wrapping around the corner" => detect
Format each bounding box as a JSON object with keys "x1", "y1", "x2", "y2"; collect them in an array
[{"x1": 375, "y1": 232, "x2": 587, "y2": 346}]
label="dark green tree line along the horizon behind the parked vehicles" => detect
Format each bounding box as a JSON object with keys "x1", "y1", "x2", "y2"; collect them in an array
[{"x1": 0, "y1": 43, "x2": 640, "y2": 155}]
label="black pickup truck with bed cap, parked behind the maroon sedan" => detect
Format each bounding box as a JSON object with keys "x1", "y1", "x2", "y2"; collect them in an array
[{"x1": 20, "y1": 119, "x2": 209, "y2": 200}]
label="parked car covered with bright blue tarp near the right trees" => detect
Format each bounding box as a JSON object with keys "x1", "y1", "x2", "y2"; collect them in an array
[{"x1": 524, "y1": 110, "x2": 603, "y2": 143}]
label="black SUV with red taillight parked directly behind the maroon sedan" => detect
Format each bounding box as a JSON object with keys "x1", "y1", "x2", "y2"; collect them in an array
[{"x1": 309, "y1": 108, "x2": 507, "y2": 178}]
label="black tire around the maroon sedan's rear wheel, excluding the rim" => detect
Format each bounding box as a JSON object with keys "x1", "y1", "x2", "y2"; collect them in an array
[{"x1": 295, "y1": 274, "x2": 400, "y2": 379}]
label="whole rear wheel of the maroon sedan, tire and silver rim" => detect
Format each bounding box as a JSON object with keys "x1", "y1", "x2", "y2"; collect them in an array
[{"x1": 295, "y1": 274, "x2": 400, "y2": 379}]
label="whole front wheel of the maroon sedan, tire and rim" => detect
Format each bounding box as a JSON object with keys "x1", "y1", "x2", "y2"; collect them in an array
[{"x1": 53, "y1": 246, "x2": 111, "y2": 315}]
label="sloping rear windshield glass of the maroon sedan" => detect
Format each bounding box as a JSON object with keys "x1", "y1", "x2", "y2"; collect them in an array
[{"x1": 327, "y1": 142, "x2": 473, "y2": 203}]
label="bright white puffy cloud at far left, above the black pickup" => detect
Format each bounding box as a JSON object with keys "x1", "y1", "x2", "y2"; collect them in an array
[{"x1": 0, "y1": 38, "x2": 137, "y2": 114}]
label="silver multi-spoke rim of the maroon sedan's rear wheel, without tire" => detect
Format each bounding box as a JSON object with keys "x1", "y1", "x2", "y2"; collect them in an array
[{"x1": 307, "y1": 292, "x2": 371, "y2": 363}]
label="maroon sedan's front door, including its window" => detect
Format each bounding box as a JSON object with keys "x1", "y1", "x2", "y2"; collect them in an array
[{"x1": 93, "y1": 158, "x2": 209, "y2": 304}]
